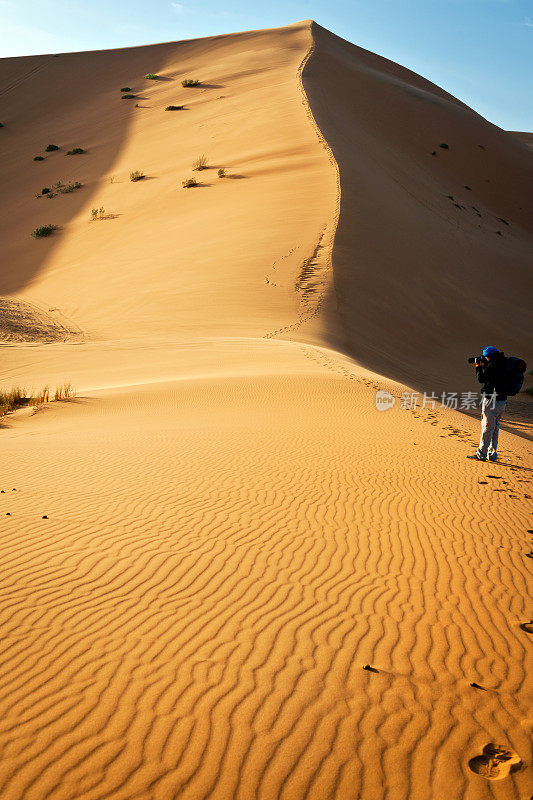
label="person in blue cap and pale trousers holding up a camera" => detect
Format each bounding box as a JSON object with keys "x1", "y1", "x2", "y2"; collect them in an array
[{"x1": 467, "y1": 347, "x2": 507, "y2": 461}]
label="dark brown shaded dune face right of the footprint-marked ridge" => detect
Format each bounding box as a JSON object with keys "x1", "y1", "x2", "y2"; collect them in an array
[{"x1": 302, "y1": 23, "x2": 533, "y2": 438}]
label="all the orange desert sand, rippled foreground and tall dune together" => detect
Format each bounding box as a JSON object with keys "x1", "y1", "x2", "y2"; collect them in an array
[{"x1": 0, "y1": 21, "x2": 533, "y2": 800}]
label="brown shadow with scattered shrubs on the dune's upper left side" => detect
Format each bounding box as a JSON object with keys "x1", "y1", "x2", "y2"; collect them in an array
[{"x1": 0, "y1": 44, "x2": 183, "y2": 295}]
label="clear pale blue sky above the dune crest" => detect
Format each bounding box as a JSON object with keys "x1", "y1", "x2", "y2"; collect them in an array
[{"x1": 0, "y1": 0, "x2": 533, "y2": 131}]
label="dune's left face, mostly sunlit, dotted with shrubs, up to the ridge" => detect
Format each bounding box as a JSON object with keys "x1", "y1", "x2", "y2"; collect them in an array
[{"x1": 0, "y1": 23, "x2": 336, "y2": 346}]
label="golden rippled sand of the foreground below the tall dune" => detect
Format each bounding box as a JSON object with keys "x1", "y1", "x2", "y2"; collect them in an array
[{"x1": 0, "y1": 370, "x2": 531, "y2": 800}]
